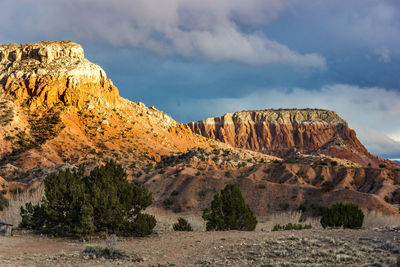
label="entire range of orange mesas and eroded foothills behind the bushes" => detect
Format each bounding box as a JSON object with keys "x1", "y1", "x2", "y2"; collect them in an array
[{"x1": 0, "y1": 42, "x2": 400, "y2": 218}]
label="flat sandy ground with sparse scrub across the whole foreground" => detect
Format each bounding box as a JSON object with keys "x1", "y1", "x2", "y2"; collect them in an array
[{"x1": 0, "y1": 230, "x2": 400, "y2": 266}]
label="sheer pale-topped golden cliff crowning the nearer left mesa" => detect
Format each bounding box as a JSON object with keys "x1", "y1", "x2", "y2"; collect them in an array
[{"x1": 0, "y1": 42, "x2": 118, "y2": 109}]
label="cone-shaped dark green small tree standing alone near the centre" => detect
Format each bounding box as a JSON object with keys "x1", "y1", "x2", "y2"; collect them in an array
[{"x1": 203, "y1": 184, "x2": 257, "y2": 231}]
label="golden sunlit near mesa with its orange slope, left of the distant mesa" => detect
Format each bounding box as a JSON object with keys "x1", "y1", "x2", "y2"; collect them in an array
[{"x1": 0, "y1": 42, "x2": 214, "y2": 180}]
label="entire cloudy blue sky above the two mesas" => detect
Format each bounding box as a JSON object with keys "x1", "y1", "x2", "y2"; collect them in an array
[{"x1": 0, "y1": 0, "x2": 400, "y2": 158}]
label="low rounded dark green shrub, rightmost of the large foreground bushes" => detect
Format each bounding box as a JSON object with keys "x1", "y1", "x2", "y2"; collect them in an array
[{"x1": 321, "y1": 203, "x2": 364, "y2": 229}]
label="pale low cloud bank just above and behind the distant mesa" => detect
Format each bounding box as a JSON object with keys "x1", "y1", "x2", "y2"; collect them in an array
[{"x1": 173, "y1": 84, "x2": 400, "y2": 158}]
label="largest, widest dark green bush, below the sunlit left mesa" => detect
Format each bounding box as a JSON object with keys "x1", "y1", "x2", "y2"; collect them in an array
[{"x1": 20, "y1": 161, "x2": 156, "y2": 237}]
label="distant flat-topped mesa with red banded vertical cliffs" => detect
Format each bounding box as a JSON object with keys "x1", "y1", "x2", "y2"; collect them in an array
[{"x1": 188, "y1": 109, "x2": 392, "y2": 166}]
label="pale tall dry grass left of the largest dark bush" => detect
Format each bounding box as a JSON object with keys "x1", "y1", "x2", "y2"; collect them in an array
[{"x1": 0, "y1": 189, "x2": 44, "y2": 226}]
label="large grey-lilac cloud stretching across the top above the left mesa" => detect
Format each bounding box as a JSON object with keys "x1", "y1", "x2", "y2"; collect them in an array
[{"x1": 0, "y1": 0, "x2": 326, "y2": 68}]
